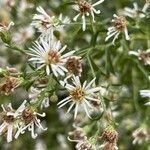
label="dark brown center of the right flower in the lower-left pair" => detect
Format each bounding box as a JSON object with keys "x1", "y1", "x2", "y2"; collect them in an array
[{"x1": 22, "y1": 108, "x2": 34, "y2": 124}]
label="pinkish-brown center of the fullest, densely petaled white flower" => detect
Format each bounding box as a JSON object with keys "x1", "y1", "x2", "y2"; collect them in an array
[{"x1": 46, "y1": 50, "x2": 61, "y2": 64}]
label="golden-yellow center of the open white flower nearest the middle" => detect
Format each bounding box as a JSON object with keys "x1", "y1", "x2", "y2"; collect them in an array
[{"x1": 70, "y1": 87, "x2": 85, "y2": 101}]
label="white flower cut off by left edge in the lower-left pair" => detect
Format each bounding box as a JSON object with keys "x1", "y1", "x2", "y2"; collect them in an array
[{"x1": 0, "y1": 101, "x2": 26, "y2": 142}]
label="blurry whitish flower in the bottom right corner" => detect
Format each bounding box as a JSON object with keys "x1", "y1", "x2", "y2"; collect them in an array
[{"x1": 132, "y1": 128, "x2": 150, "y2": 144}]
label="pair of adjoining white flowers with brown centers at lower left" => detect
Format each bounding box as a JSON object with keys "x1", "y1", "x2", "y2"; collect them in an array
[{"x1": 0, "y1": 100, "x2": 46, "y2": 142}]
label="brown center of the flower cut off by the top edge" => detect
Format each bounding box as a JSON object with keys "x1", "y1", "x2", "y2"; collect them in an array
[{"x1": 78, "y1": 0, "x2": 92, "y2": 13}]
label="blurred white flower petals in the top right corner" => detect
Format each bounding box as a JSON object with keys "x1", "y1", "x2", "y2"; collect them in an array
[{"x1": 123, "y1": 2, "x2": 149, "y2": 18}]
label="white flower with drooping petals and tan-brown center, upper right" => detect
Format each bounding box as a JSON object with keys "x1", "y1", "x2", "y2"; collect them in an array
[{"x1": 105, "y1": 14, "x2": 130, "y2": 45}]
